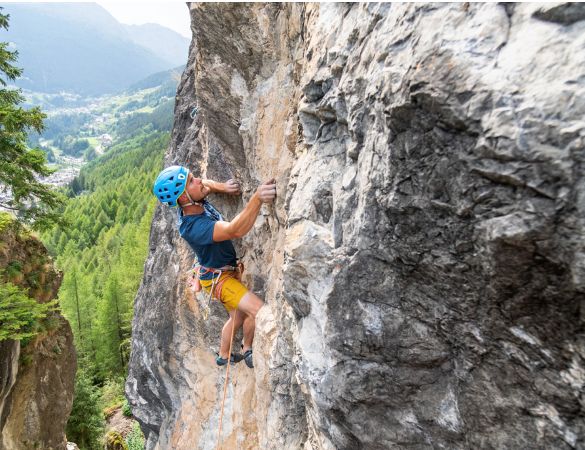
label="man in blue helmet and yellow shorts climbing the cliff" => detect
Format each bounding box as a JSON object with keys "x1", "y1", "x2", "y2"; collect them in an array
[{"x1": 154, "y1": 166, "x2": 276, "y2": 368}]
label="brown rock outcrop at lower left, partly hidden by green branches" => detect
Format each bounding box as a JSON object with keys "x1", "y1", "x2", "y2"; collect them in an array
[{"x1": 0, "y1": 226, "x2": 77, "y2": 450}]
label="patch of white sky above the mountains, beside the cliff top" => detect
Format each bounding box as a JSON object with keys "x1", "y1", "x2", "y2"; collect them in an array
[{"x1": 97, "y1": 1, "x2": 191, "y2": 39}]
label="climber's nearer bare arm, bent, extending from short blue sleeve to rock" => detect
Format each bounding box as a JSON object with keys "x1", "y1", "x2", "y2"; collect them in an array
[{"x1": 212, "y1": 178, "x2": 276, "y2": 242}]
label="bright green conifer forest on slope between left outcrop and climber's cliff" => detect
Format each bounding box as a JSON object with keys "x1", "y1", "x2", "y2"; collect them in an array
[{"x1": 41, "y1": 133, "x2": 163, "y2": 385}]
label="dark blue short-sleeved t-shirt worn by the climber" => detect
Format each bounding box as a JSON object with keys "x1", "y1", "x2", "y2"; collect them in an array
[{"x1": 177, "y1": 202, "x2": 237, "y2": 280}]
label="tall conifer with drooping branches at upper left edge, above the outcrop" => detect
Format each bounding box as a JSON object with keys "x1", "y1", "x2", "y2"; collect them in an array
[{"x1": 0, "y1": 9, "x2": 67, "y2": 230}]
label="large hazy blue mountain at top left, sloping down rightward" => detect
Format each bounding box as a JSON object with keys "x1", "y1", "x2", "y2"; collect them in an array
[{"x1": 0, "y1": 3, "x2": 186, "y2": 96}]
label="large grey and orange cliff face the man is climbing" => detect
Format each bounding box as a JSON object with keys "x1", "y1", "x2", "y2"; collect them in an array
[{"x1": 126, "y1": 3, "x2": 585, "y2": 450}]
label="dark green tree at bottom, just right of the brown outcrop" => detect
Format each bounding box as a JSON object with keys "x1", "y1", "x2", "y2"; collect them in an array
[{"x1": 67, "y1": 369, "x2": 104, "y2": 450}]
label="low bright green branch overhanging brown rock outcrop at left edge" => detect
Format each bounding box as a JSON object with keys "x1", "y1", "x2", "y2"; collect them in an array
[{"x1": 0, "y1": 278, "x2": 57, "y2": 341}]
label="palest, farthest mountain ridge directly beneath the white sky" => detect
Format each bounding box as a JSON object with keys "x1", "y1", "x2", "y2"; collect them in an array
[{"x1": 122, "y1": 23, "x2": 191, "y2": 67}]
